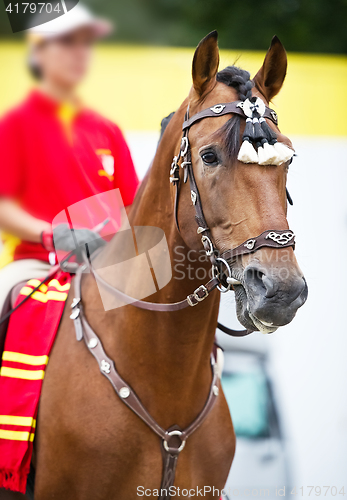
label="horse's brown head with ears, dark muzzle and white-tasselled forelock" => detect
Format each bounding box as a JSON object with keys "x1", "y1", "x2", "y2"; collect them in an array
[{"x1": 171, "y1": 32, "x2": 308, "y2": 333}]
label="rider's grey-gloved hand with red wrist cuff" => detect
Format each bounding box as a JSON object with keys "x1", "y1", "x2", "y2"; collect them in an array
[{"x1": 41, "y1": 224, "x2": 106, "y2": 255}]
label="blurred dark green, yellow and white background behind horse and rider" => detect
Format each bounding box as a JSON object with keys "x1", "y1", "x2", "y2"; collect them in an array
[{"x1": 0, "y1": 0, "x2": 347, "y2": 498}]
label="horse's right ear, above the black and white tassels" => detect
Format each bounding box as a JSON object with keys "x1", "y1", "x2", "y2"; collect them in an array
[{"x1": 253, "y1": 35, "x2": 287, "y2": 102}]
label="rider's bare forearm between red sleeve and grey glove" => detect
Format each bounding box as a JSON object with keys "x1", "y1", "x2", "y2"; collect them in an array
[{"x1": 0, "y1": 197, "x2": 51, "y2": 243}]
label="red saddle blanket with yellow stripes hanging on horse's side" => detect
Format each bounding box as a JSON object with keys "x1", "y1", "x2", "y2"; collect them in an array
[{"x1": 0, "y1": 271, "x2": 71, "y2": 493}]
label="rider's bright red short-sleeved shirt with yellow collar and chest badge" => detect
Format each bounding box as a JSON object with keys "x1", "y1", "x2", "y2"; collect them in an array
[{"x1": 0, "y1": 91, "x2": 138, "y2": 267}]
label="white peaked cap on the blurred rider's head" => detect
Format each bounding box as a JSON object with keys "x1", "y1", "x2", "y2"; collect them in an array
[{"x1": 27, "y1": 2, "x2": 113, "y2": 44}]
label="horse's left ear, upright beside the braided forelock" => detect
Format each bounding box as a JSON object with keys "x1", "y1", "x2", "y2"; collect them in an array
[{"x1": 192, "y1": 31, "x2": 219, "y2": 97}]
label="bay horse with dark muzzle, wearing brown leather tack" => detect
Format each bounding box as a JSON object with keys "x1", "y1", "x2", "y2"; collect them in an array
[{"x1": 14, "y1": 32, "x2": 307, "y2": 500}]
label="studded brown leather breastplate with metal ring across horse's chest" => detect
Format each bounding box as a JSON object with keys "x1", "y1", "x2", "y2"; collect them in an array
[{"x1": 70, "y1": 266, "x2": 220, "y2": 500}]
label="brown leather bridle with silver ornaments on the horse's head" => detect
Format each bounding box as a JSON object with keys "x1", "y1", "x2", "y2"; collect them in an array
[{"x1": 170, "y1": 101, "x2": 295, "y2": 292}]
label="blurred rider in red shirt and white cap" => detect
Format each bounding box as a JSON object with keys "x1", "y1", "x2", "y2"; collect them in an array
[{"x1": 0, "y1": 4, "x2": 138, "y2": 311}]
